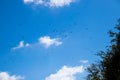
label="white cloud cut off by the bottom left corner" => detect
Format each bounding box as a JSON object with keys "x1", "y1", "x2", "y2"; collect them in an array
[{"x1": 0, "y1": 72, "x2": 24, "y2": 80}]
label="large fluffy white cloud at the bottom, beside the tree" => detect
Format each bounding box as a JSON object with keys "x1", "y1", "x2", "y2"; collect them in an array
[{"x1": 45, "y1": 66, "x2": 84, "y2": 80}]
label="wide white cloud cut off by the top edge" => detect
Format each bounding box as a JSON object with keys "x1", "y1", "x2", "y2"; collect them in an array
[{"x1": 23, "y1": 0, "x2": 75, "y2": 7}]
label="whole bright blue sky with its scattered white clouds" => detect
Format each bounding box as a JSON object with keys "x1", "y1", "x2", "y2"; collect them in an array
[{"x1": 0, "y1": 0, "x2": 120, "y2": 80}]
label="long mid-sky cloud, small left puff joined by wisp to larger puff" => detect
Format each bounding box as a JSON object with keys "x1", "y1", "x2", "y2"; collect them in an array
[{"x1": 12, "y1": 36, "x2": 62, "y2": 50}]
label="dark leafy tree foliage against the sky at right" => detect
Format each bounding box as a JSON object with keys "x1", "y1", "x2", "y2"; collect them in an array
[{"x1": 87, "y1": 19, "x2": 120, "y2": 80}]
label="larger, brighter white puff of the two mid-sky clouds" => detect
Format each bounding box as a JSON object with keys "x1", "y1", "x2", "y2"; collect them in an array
[{"x1": 38, "y1": 36, "x2": 62, "y2": 48}]
